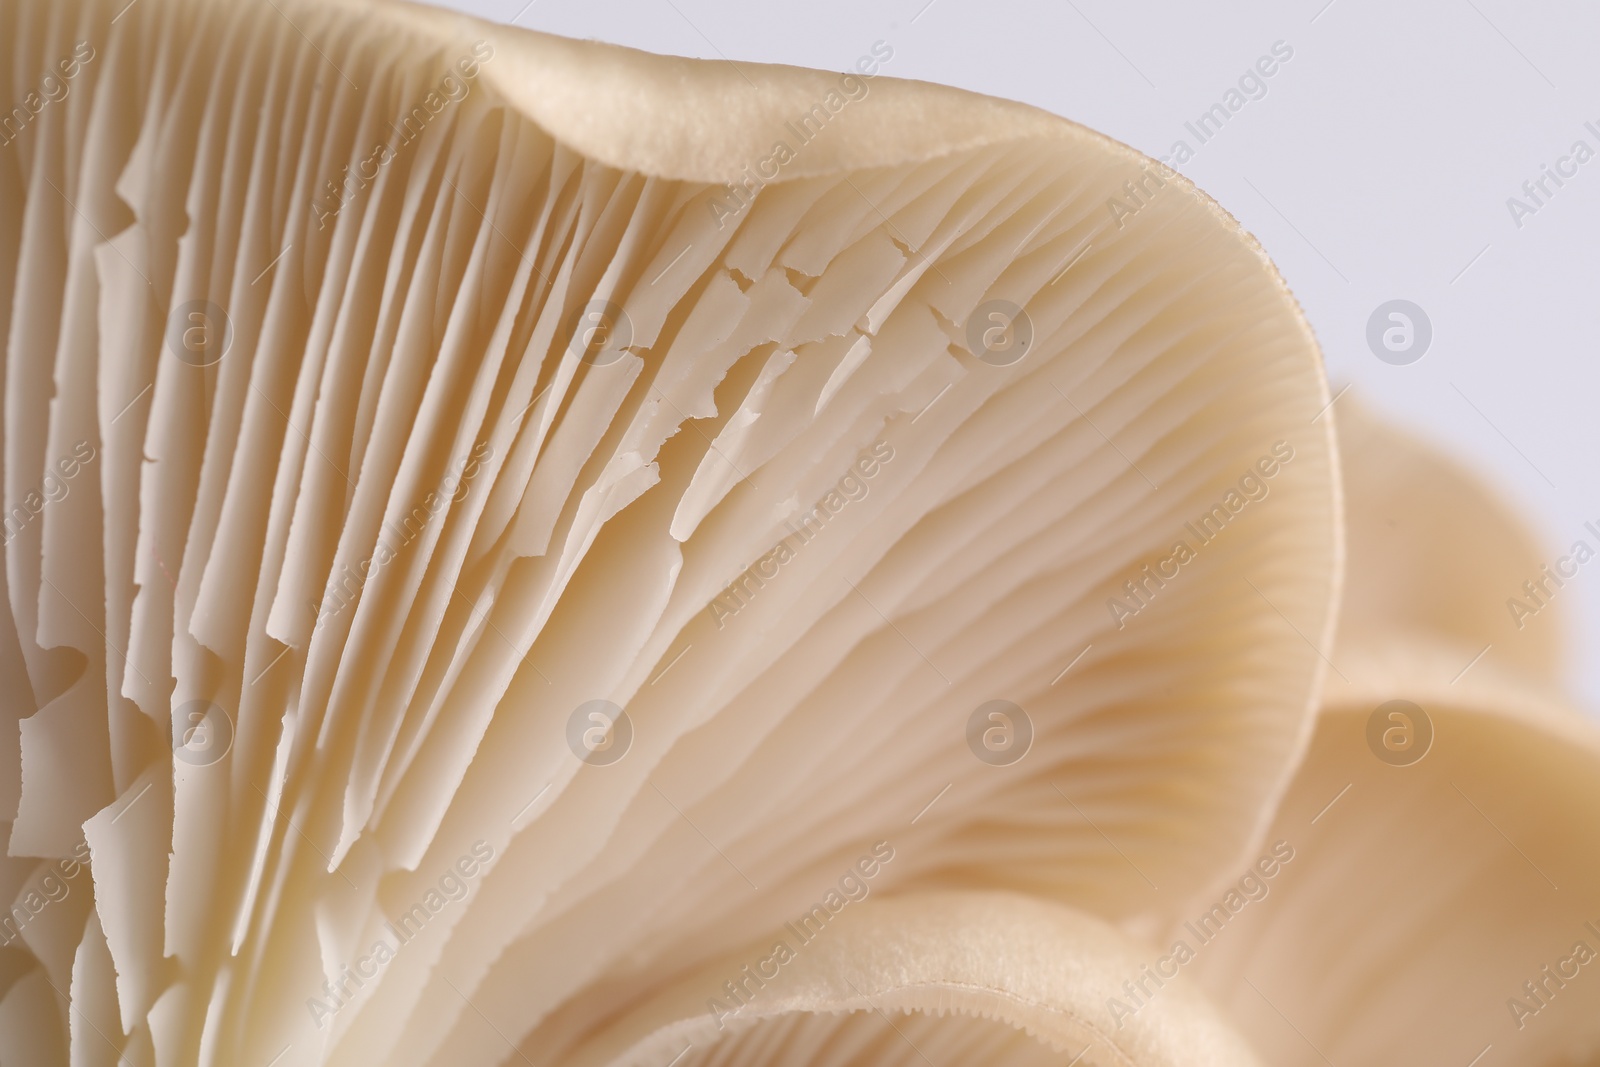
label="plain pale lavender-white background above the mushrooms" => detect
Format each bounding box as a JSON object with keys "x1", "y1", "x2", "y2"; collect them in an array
[{"x1": 425, "y1": 0, "x2": 1600, "y2": 710}]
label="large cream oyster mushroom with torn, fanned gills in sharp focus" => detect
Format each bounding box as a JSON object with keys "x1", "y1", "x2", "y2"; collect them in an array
[{"x1": 0, "y1": 0, "x2": 1363, "y2": 1064}]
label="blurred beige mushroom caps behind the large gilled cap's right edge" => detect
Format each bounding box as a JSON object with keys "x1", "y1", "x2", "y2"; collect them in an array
[{"x1": 1190, "y1": 397, "x2": 1600, "y2": 1067}]
